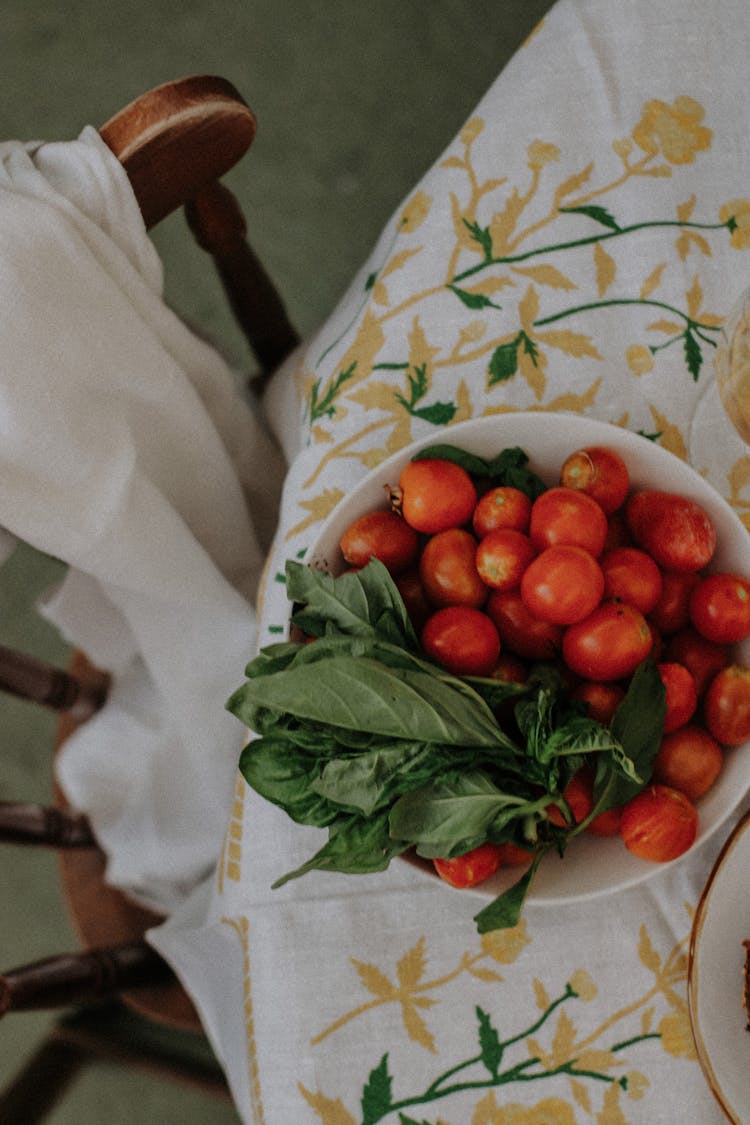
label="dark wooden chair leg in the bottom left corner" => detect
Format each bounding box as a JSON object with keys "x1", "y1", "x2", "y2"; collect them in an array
[{"x1": 0, "y1": 1032, "x2": 87, "y2": 1125}]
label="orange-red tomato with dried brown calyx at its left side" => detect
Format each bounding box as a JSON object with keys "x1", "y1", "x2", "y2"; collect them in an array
[{"x1": 398, "y1": 458, "x2": 477, "y2": 536}]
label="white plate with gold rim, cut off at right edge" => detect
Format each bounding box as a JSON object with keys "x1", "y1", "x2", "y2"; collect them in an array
[{"x1": 687, "y1": 810, "x2": 750, "y2": 1125}]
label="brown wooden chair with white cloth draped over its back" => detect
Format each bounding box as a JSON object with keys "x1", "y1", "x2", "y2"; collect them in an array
[{"x1": 0, "y1": 75, "x2": 298, "y2": 1125}]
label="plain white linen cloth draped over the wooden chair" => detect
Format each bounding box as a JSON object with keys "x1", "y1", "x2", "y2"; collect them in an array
[{"x1": 0, "y1": 127, "x2": 282, "y2": 911}]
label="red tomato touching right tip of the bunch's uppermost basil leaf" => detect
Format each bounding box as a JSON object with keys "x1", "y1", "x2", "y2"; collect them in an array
[{"x1": 422, "y1": 605, "x2": 500, "y2": 676}]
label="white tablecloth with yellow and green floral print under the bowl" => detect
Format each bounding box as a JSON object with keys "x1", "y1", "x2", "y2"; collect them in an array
[{"x1": 152, "y1": 0, "x2": 750, "y2": 1125}]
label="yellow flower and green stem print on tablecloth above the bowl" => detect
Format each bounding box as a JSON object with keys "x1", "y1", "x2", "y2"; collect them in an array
[{"x1": 270, "y1": 96, "x2": 750, "y2": 562}]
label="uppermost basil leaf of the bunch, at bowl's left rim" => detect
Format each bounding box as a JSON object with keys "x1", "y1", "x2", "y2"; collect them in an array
[{"x1": 287, "y1": 559, "x2": 419, "y2": 651}]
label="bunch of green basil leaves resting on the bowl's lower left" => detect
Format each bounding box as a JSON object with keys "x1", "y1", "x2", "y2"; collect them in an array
[{"x1": 227, "y1": 559, "x2": 665, "y2": 933}]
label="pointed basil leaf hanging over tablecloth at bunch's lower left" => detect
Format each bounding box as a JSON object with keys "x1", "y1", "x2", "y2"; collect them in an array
[{"x1": 273, "y1": 810, "x2": 408, "y2": 889}]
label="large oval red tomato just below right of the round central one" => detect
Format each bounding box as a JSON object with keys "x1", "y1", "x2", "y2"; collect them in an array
[{"x1": 562, "y1": 602, "x2": 653, "y2": 681}]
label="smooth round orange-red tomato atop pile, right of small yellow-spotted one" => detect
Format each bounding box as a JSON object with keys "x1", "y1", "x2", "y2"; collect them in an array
[{"x1": 521, "y1": 546, "x2": 604, "y2": 626}]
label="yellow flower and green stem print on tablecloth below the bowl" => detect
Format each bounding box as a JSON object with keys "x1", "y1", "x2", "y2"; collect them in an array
[{"x1": 299, "y1": 921, "x2": 696, "y2": 1125}]
